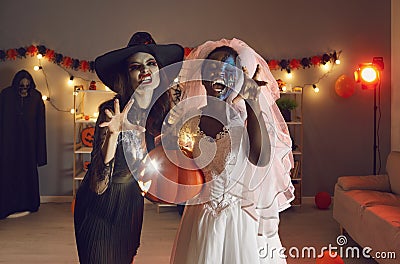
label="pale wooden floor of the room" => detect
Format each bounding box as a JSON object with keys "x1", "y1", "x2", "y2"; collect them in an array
[{"x1": 0, "y1": 203, "x2": 376, "y2": 264}]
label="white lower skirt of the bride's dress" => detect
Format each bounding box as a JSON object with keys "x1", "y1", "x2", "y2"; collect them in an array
[{"x1": 171, "y1": 202, "x2": 286, "y2": 264}]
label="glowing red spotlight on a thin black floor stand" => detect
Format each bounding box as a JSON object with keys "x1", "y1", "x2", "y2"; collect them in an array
[{"x1": 354, "y1": 57, "x2": 384, "y2": 175}]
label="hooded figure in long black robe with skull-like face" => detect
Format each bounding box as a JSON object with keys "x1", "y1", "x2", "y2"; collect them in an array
[{"x1": 0, "y1": 70, "x2": 47, "y2": 219}]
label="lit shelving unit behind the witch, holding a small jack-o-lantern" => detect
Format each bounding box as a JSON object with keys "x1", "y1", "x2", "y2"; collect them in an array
[{"x1": 72, "y1": 86, "x2": 115, "y2": 197}]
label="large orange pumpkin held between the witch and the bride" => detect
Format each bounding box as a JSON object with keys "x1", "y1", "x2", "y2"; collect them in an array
[{"x1": 139, "y1": 145, "x2": 204, "y2": 204}]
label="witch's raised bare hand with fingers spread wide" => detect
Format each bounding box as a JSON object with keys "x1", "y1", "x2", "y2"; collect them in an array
[{"x1": 99, "y1": 98, "x2": 146, "y2": 134}]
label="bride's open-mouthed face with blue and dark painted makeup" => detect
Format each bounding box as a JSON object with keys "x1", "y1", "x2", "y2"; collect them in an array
[{"x1": 203, "y1": 52, "x2": 238, "y2": 101}]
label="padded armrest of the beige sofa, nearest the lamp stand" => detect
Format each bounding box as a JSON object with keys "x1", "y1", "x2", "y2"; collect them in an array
[{"x1": 337, "y1": 174, "x2": 391, "y2": 192}]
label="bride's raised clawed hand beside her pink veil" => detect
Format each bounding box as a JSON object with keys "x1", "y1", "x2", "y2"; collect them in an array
[{"x1": 233, "y1": 64, "x2": 267, "y2": 103}]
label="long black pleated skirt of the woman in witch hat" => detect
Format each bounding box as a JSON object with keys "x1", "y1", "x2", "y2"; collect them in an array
[{"x1": 74, "y1": 179, "x2": 144, "y2": 264}]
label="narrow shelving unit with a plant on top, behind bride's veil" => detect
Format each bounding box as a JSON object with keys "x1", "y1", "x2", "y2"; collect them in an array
[{"x1": 281, "y1": 90, "x2": 303, "y2": 206}]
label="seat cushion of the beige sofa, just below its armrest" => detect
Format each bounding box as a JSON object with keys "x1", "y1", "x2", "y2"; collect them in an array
[{"x1": 344, "y1": 190, "x2": 400, "y2": 207}]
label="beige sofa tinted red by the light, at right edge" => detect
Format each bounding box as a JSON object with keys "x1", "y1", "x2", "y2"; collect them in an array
[{"x1": 333, "y1": 151, "x2": 400, "y2": 263}]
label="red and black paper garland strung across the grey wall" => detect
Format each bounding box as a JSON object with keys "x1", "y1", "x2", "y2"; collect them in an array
[{"x1": 0, "y1": 45, "x2": 341, "y2": 73}]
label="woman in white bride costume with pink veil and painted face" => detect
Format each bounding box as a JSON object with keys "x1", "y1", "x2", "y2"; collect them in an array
[{"x1": 169, "y1": 39, "x2": 294, "y2": 264}]
